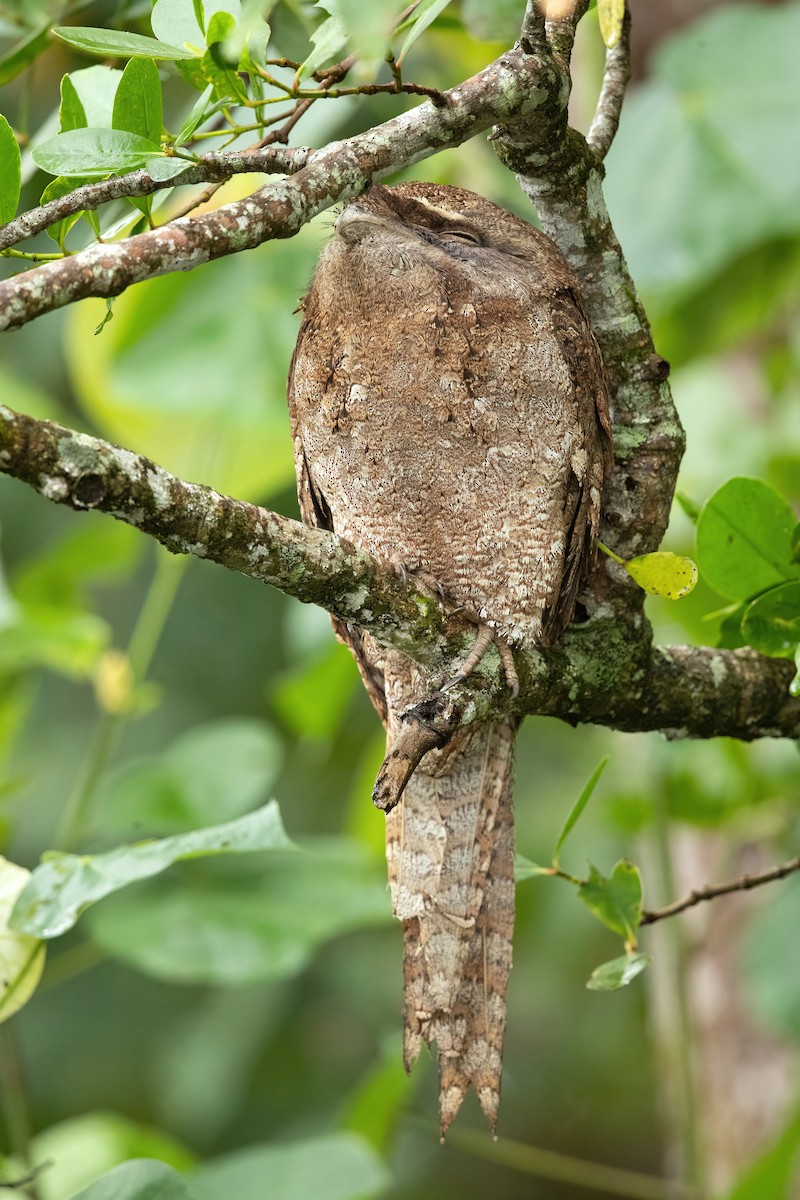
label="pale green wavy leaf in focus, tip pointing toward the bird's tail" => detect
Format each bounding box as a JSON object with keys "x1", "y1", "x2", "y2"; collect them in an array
[{"x1": 11, "y1": 800, "x2": 293, "y2": 937}]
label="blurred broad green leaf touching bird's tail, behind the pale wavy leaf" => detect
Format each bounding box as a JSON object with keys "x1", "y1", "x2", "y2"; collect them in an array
[{"x1": 88, "y1": 838, "x2": 391, "y2": 986}]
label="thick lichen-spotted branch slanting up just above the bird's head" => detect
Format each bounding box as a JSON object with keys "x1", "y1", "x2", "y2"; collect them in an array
[{"x1": 0, "y1": 49, "x2": 553, "y2": 329}]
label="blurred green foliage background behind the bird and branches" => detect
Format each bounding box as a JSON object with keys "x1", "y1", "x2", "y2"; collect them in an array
[{"x1": 0, "y1": 0, "x2": 800, "y2": 1200}]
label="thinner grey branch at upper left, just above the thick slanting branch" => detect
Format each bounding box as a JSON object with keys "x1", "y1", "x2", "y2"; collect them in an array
[{"x1": 0, "y1": 146, "x2": 312, "y2": 250}]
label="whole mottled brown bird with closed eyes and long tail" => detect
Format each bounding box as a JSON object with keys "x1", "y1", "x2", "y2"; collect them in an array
[{"x1": 289, "y1": 184, "x2": 610, "y2": 1130}]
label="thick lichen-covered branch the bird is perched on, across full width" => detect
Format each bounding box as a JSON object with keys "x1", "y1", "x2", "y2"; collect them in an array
[{"x1": 6, "y1": 407, "x2": 800, "y2": 739}]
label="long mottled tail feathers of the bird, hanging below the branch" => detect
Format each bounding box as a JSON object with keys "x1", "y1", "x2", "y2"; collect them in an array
[{"x1": 386, "y1": 724, "x2": 515, "y2": 1136}]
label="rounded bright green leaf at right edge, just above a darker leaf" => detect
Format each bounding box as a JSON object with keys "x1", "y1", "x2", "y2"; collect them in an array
[{"x1": 697, "y1": 475, "x2": 800, "y2": 600}]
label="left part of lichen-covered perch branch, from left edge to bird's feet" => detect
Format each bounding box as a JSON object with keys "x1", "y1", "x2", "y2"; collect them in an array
[{"x1": 0, "y1": 406, "x2": 446, "y2": 655}]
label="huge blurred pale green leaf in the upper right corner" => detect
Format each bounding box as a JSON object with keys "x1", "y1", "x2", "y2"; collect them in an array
[{"x1": 606, "y1": 4, "x2": 800, "y2": 300}]
